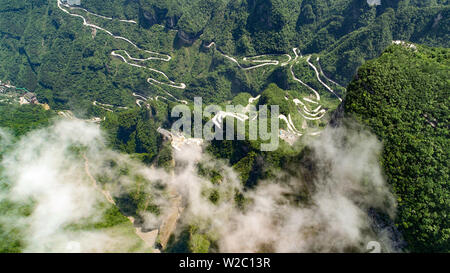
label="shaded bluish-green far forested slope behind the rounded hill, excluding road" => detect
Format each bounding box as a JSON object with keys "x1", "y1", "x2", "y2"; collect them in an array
[{"x1": 0, "y1": 0, "x2": 450, "y2": 112}]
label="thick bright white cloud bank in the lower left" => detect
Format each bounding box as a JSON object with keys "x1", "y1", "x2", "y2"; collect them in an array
[{"x1": 0, "y1": 121, "x2": 142, "y2": 252}]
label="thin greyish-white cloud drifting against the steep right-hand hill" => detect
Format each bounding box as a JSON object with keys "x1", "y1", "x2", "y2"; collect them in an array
[{"x1": 169, "y1": 124, "x2": 395, "y2": 252}]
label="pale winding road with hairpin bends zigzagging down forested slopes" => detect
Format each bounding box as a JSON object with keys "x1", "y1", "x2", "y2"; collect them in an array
[{"x1": 57, "y1": 0, "x2": 342, "y2": 142}]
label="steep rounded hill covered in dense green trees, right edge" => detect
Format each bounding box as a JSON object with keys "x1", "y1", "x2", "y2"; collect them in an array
[{"x1": 343, "y1": 44, "x2": 450, "y2": 252}]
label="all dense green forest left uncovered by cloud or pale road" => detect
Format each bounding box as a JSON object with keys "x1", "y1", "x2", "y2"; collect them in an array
[{"x1": 0, "y1": 0, "x2": 450, "y2": 252}]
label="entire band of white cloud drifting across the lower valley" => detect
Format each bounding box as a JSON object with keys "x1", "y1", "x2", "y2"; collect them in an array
[{"x1": 0, "y1": 121, "x2": 395, "y2": 252}]
